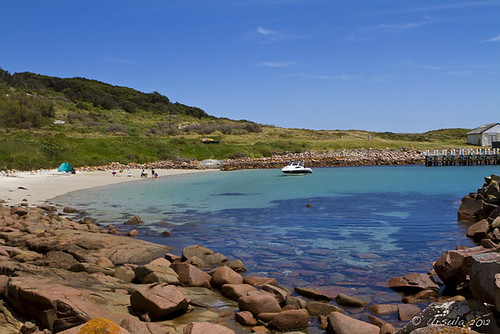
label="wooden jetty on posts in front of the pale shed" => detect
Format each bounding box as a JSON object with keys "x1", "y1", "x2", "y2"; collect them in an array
[{"x1": 425, "y1": 148, "x2": 500, "y2": 166}]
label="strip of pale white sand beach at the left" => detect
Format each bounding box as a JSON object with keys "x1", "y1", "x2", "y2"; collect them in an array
[{"x1": 0, "y1": 169, "x2": 214, "y2": 206}]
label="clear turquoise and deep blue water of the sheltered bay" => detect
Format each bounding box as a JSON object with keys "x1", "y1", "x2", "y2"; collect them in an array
[{"x1": 55, "y1": 166, "x2": 500, "y2": 302}]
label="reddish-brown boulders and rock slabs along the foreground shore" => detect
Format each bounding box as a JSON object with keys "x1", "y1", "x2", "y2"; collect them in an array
[{"x1": 0, "y1": 175, "x2": 500, "y2": 334}]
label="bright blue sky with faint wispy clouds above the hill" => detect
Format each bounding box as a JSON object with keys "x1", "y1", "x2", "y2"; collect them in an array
[{"x1": 0, "y1": 0, "x2": 500, "y2": 132}]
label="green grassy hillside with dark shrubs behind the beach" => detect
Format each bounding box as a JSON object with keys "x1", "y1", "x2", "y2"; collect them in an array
[{"x1": 0, "y1": 69, "x2": 470, "y2": 170}]
